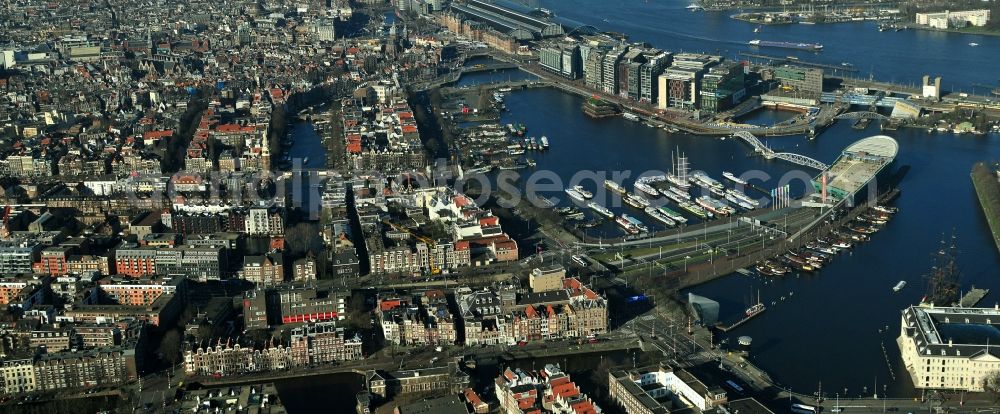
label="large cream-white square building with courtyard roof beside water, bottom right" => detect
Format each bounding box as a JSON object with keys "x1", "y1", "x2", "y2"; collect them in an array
[{"x1": 896, "y1": 306, "x2": 1000, "y2": 391}]
